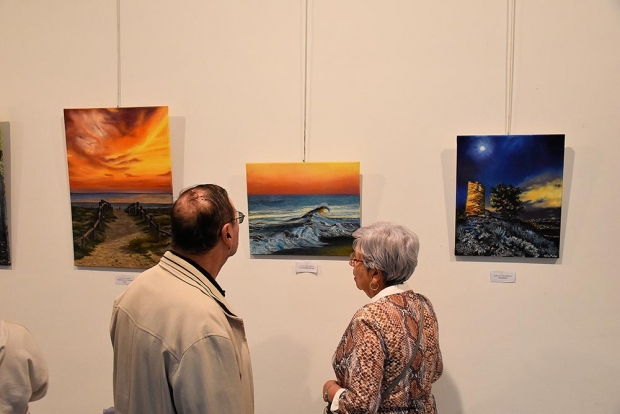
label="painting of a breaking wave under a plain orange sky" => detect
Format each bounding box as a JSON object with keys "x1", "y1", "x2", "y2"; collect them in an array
[{"x1": 246, "y1": 162, "x2": 360, "y2": 256}]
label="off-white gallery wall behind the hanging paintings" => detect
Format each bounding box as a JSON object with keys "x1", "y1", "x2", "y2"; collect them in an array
[{"x1": 0, "y1": 0, "x2": 620, "y2": 414}]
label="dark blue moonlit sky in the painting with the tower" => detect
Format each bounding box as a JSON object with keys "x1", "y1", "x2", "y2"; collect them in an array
[{"x1": 456, "y1": 135, "x2": 564, "y2": 217}]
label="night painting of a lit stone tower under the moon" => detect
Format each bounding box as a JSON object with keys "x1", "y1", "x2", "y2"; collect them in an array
[{"x1": 455, "y1": 134, "x2": 565, "y2": 258}]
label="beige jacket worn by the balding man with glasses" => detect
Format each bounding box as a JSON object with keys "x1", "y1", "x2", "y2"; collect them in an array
[{"x1": 110, "y1": 252, "x2": 254, "y2": 414}]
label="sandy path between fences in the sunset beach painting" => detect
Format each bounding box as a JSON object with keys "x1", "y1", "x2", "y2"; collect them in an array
[{"x1": 74, "y1": 210, "x2": 155, "y2": 268}]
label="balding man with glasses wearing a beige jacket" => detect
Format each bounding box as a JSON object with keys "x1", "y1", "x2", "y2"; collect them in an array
[{"x1": 110, "y1": 184, "x2": 254, "y2": 414}]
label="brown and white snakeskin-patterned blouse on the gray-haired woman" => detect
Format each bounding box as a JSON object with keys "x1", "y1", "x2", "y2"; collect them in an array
[{"x1": 332, "y1": 288, "x2": 443, "y2": 414}]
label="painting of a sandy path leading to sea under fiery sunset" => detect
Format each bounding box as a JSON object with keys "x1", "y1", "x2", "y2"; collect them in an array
[{"x1": 64, "y1": 106, "x2": 172, "y2": 268}]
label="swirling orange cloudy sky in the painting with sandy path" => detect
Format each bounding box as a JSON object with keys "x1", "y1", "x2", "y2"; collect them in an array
[{"x1": 64, "y1": 106, "x2": 172, "y2": 193}]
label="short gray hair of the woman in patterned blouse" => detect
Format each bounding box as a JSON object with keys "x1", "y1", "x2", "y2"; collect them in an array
[{"x1": 353, "y1": 221, "x2": 420, "y2": 286}]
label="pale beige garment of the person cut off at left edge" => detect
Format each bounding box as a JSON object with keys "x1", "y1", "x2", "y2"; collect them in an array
[{"x1": 0, "y1": 320, "x2": 48, "y2": 414}]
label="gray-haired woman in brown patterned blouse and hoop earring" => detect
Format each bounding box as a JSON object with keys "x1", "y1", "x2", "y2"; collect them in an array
[{"x1": 323, "y1": 222, "x2": 443, "y2": 414}]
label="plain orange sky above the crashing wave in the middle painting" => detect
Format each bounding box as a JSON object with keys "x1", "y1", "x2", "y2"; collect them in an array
[{"x1": 246, "y1": 162, "x2": 360, "y2": 195}]
